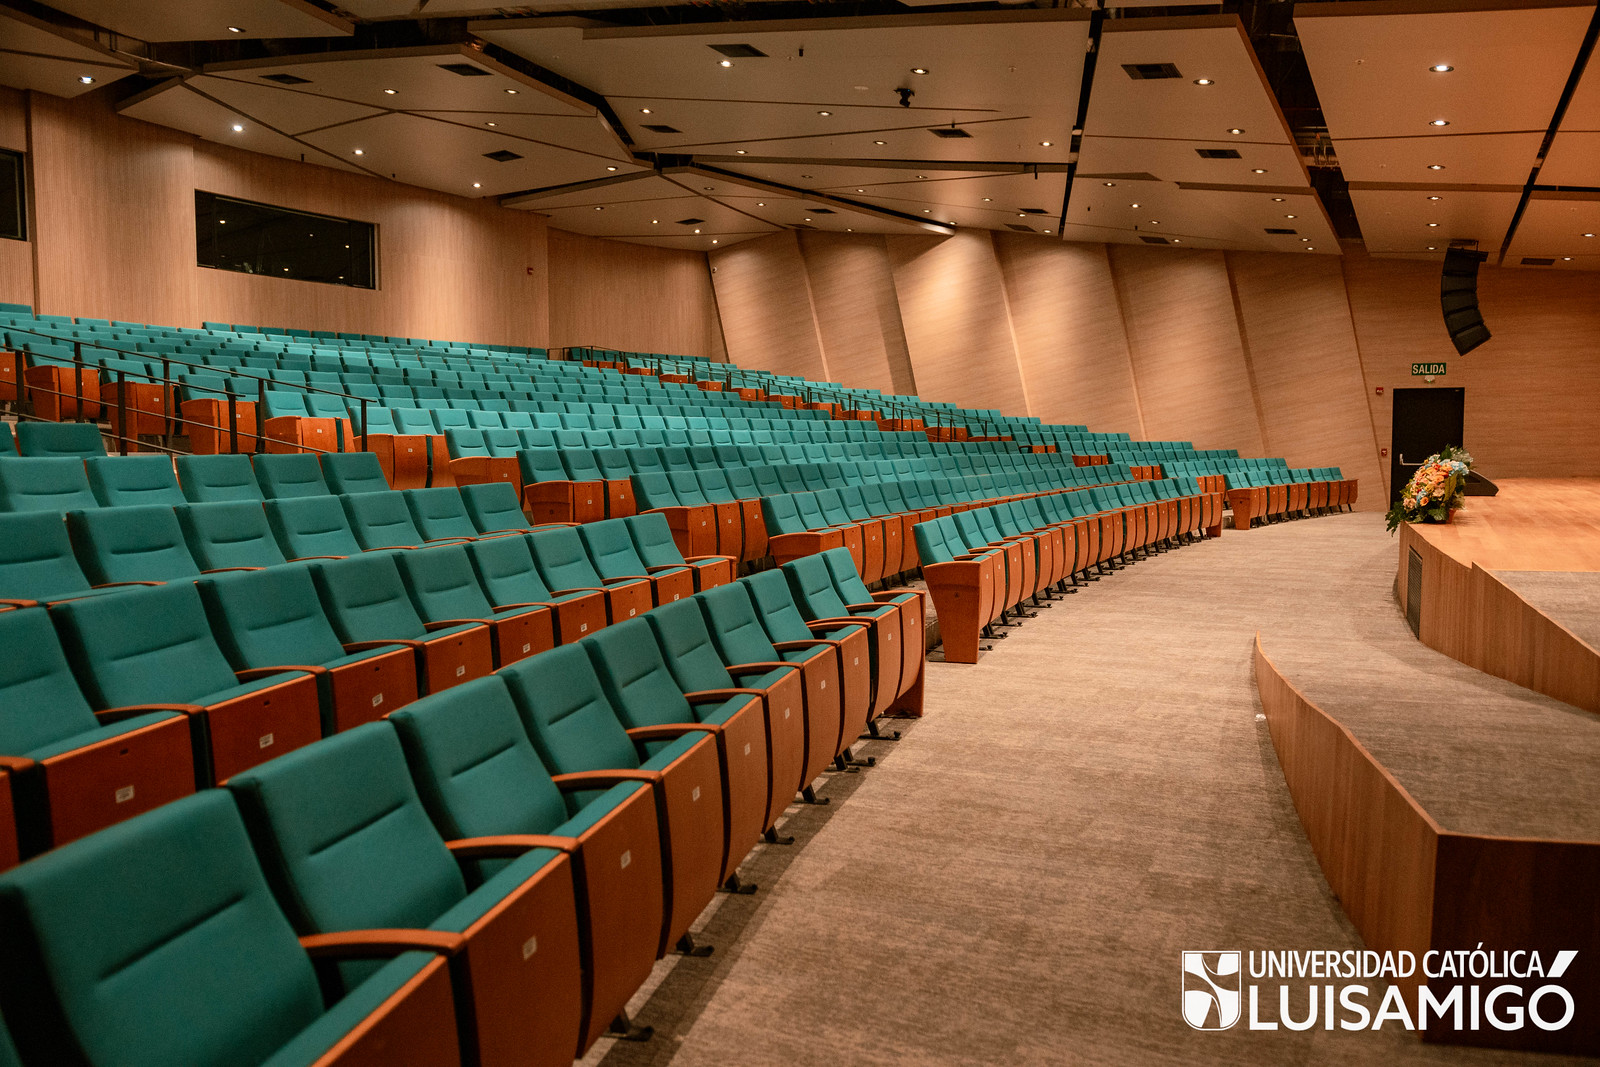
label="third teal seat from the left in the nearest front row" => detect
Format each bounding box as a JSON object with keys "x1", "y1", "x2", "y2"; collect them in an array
[{"x1": 389, "y1": 675, "x2": 664, "y2": 1056}]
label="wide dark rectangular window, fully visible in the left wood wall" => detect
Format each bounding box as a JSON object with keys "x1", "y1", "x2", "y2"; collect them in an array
[{"x1": 195, "y1": 190, "x2": 378, "y2": 290}]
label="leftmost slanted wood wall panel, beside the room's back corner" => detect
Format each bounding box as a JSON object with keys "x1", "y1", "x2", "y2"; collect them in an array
[{"x1": 710, "y1": 230, "x2": 832, "y2": 381}]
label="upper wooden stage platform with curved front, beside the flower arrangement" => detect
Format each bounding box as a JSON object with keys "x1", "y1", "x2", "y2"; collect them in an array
[{"x1": 1395, "y1": 478, "x2": 1600, "y2": 713}]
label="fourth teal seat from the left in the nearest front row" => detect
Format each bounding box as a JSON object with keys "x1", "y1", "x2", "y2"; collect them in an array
[{"x1": 498, "y1": 645, "x2": 726, "y2": 957}]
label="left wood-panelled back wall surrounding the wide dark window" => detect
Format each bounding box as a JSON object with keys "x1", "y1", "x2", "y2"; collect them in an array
[{"x1": 0, "y1": 90, "x2": 722, "y2": 358}]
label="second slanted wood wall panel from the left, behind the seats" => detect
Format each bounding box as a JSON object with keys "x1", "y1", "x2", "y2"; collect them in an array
[{"x1": 800, "y1": 232, "x2": 915, "y2": 394}]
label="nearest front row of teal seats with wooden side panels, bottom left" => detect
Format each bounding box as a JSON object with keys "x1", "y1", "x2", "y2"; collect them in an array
[{"x1": 0, "y1": 550, "x2": 928, "y2": 1067}]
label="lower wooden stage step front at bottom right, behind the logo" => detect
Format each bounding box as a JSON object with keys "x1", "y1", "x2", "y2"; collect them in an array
[{"x1": 1254, "y1": 633, "x2": 1600, "y2": 1056}]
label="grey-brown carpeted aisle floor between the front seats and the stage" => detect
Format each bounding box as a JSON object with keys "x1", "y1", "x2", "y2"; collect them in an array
[{"x1": 589, "y1": 514, "x2": 1600, "y2": 1067}]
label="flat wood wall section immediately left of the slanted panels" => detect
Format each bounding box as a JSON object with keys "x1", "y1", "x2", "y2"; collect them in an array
[{"x1": 549, "y1": 229, "x2": 720, "y2": 358}]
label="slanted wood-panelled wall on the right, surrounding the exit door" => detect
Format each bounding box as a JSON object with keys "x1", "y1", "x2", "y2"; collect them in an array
[{"x1": 712, "y1": 232, "x2": 1600, "y2": 510}]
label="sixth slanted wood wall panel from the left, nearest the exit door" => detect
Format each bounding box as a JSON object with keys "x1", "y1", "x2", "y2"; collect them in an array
[{"x1": 1227, "y1": 253, "x2": 1384, "y2": 510}]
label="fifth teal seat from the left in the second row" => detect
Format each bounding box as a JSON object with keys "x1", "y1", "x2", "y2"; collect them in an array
[{"x1": 395, "y1": 544, "x2": 555, "y2": 667}]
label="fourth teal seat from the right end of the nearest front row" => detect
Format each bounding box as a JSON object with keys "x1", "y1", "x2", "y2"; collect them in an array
[{"x1": 694, "y1": 584, "x2": 851, "y2": 803}]
